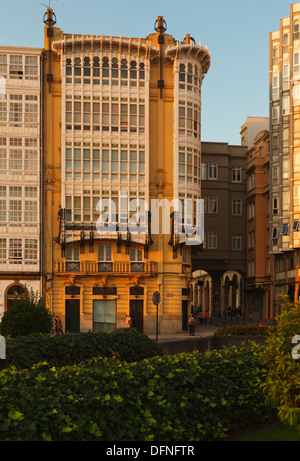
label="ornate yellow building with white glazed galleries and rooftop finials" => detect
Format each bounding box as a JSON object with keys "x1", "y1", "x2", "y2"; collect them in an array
[{"x1": 42, "y1": 8, "x2": 210, "y2": 333}]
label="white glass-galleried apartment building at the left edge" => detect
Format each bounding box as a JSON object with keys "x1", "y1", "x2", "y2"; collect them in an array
[{"x1": 0, "y1": 46, "x2": 42, "y2": 316}]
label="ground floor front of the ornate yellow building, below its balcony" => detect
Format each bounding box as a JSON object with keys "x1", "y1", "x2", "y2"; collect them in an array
[{"x1": 46, "y1": 274, "x2": 191, "y2": 334}]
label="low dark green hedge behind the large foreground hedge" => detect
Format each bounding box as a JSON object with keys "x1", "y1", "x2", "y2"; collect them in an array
[{"x1": 0, "y1": 328, "x2": 164, "y2": 369}]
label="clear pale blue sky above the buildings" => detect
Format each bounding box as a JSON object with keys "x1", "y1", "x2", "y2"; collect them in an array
[{"x1": 0, "y1": 0, "x2": 297, "y2": 145}]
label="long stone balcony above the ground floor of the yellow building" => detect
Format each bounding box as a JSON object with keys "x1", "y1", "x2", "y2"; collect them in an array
[{"x1": 55, "y1": 260, "x2": 157, "y2": 276}]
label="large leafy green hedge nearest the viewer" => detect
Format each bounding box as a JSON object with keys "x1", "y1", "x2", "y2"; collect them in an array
[{"x1": 0, "y1": 348, "x2": 269, "y2": 442}]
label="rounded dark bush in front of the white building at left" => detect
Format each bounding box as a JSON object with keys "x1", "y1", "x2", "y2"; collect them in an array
[{"x1": 0, "y1": 291, "x2": 53, "y2": 338}]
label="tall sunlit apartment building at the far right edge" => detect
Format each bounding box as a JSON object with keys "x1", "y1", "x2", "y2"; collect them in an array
[{"x1": 269, "y1": 3, "x2": 300, "y2": 314}]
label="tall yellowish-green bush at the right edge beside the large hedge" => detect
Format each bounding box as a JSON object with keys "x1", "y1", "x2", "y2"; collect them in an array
[{"x1": 262, "y1": 296, "x2": 300, "y2": 429}]
